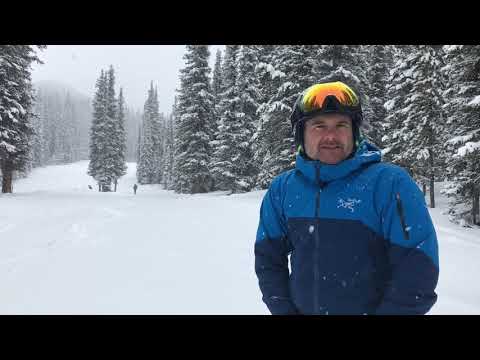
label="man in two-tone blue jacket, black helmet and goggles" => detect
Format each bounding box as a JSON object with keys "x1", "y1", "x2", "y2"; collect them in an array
[{"x1": 255, "y1": 82, "x2": 439, "y2": 315}]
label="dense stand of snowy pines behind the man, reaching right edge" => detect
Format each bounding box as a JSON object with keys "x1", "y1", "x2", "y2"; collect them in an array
[{"x1": 139, "y1": 45, "x2": 480, "y2": 224}]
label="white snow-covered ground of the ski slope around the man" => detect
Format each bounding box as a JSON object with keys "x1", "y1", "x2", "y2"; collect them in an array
[{"x1": 0, "y1": 162, "x2": 480, "y2": 314}]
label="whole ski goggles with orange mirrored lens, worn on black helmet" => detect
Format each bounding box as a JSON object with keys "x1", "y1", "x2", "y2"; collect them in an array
[{"x1": 298, "y1": 81, "x2": 360, "y2": 115}]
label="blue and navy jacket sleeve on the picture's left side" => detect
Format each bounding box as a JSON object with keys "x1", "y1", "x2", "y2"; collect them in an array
[{"x1": 255, "y1": 178, "x2": 297, "y2": 315}]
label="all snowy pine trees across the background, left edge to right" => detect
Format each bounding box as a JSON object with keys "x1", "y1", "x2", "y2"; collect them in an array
[{"x1": 0, "y1": 45, "x2": 480, "y2": 224}]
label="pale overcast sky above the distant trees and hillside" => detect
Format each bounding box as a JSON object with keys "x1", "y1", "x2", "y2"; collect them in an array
[{"x1": 32, "y1": 45, "x2": 224, "y2": 113}]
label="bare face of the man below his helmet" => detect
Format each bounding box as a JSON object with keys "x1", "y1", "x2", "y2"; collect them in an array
[{"x1": 304, "y1": 114, "x2": 353, "y2": 164}]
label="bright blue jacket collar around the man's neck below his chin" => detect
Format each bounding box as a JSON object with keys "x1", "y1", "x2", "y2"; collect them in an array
[{"x1": 295, "y1": 141, "x2": 381, "y2": 184}]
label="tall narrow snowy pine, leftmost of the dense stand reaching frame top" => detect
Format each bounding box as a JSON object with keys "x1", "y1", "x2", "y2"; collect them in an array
[{"x1": 174, "y1": 45, "x2": 215, "y2": 194}]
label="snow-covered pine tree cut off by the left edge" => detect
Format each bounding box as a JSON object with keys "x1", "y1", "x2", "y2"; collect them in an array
[{"x1": 0, "y1": 45, "x2": 45, "y2": 193}]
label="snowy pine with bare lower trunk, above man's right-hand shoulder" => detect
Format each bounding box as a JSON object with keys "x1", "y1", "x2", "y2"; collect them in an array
[{"x1": 384, "y1": 45, "x2": 445, "y2": 208}]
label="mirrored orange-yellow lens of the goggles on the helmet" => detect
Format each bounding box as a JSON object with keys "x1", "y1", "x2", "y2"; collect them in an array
[{"x1": 301, "y1": 81, "x2": 359, "y2": 112}]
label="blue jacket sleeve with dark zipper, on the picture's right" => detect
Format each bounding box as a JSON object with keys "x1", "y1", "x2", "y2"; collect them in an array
[{"x1": 376, "y1": 169, "x2": 439, "y2": 315}]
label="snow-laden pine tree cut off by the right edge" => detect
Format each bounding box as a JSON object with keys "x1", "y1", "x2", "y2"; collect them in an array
[{"x1": 444, "y1": 45, "x2": 480, "y2": 225}]
